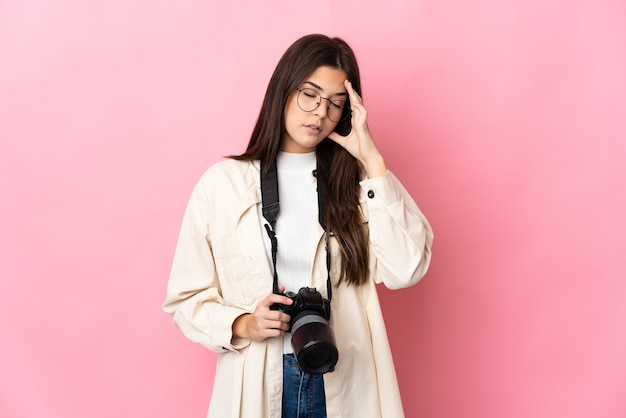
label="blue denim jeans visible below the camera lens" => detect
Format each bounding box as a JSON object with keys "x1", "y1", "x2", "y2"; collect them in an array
[{"x1": 282, "y1": 354, "x2": 326, "y2": 418}]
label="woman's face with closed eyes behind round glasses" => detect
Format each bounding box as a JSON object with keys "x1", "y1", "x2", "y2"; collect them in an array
[{"x1": 281, "y1": 67, "x2": 348, "y2": 153}]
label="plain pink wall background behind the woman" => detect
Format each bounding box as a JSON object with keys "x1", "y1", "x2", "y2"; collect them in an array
[{"x1": 0, "y1": 0, "x2": 626, "y2": 418}]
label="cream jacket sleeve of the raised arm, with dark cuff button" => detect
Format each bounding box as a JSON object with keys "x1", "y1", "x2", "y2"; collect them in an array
[{"x1": 360, "y1": 171, "x2": 433, "y2": 289}]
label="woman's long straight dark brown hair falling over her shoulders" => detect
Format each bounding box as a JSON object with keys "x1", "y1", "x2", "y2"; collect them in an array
[{"x1": 230, "y1": 34, "x2": 368, "y2": 285}]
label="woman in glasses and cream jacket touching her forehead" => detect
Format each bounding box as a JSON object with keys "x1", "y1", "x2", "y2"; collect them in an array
[{"x1": 164, "y1": 35, "x2": 433, "y2": 418}]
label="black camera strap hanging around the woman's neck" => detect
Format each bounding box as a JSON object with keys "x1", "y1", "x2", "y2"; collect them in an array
[{"x1": 261, "y1": 160, "x2": 332, "y2": 301}]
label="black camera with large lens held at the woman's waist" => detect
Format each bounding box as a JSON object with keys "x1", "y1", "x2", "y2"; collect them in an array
[{"x1": 271, "y1": 287, "x2": 339, "y2": 374}]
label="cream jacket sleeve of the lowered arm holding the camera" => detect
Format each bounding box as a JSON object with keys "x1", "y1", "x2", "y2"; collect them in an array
[{"x1": 163, "y1": 176, "x2": 250, "y2": 353}]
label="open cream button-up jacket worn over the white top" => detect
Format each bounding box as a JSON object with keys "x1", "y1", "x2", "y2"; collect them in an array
[{"x1": 163, "y1": 160, "x2": 433, "y2": 418}]
